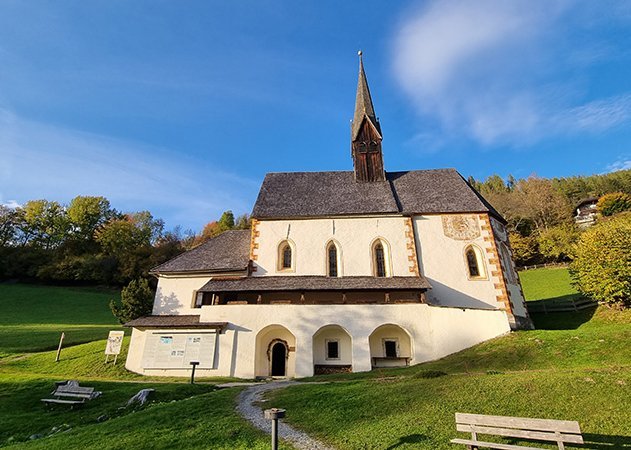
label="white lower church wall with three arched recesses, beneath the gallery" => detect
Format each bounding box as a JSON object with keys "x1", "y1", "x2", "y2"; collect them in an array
[{"x1": 126, "y1": 304, "x2": 509, "y2": 378}]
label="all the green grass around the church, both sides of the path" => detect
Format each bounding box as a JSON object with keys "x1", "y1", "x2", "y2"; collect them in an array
[{"x1": 0, "y1": 269, "x2": 631, "y2": 449}]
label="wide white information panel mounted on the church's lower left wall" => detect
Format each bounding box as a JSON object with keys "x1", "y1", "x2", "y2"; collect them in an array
[{"x1": 143, "y1": 331, "x2": 217, "y2": 369}]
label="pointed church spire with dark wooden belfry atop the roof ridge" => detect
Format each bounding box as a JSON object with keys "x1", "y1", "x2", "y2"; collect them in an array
[{"x1": 351, "y1": 50, "x2": 386, "y2": 182}]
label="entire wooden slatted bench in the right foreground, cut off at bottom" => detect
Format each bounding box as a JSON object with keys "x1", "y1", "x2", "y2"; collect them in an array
[{"x1": 451, "y1": 413, "x2": 583, "y2": 450}]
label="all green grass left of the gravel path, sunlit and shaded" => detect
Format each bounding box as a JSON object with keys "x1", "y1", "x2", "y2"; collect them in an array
[{"x1": 0, "y1": 284, "x2": 290, "y2": 450}]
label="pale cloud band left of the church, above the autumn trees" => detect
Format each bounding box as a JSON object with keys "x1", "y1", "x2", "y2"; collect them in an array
[{"x1": 0, "y1": 109, "x2": 258, "y2": 229}]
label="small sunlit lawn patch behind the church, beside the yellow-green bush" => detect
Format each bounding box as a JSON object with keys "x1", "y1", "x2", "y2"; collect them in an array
[{"x1": 519, "y1": 267, "x2": 580, "y2": 301}]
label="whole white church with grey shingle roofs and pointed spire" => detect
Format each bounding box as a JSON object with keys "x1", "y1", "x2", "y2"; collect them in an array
[{"x1": 126, "y1": 56, "x2": 532, "y2": 378}]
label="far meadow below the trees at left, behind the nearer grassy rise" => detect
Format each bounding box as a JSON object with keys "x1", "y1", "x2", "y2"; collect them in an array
[{"x1": 0, "y1": 284, "x2": 120, "y2": 357}]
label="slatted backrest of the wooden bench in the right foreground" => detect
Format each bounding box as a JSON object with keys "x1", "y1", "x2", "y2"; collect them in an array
[{"x1": 456, "y1": 413, "x2": 583, "y2": 444}]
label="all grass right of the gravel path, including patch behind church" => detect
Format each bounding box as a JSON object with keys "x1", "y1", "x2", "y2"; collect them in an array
[{"x1": 269, "y1": 269, "x2": 631, "y2": 450}]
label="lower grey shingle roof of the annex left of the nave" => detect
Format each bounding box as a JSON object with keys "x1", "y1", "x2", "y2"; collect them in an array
[{"x1": 151, "y1": 230, "x2": 250, "y2": 273}]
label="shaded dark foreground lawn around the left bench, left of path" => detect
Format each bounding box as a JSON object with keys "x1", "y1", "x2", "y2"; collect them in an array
[{"x1": 0, "y1": 376, "x2": 290, "y2": 450}]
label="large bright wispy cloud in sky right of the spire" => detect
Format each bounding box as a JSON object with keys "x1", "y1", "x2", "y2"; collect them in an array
[{"x1": 393, "y1": 0, "x2": 631, "y2": 146}]
